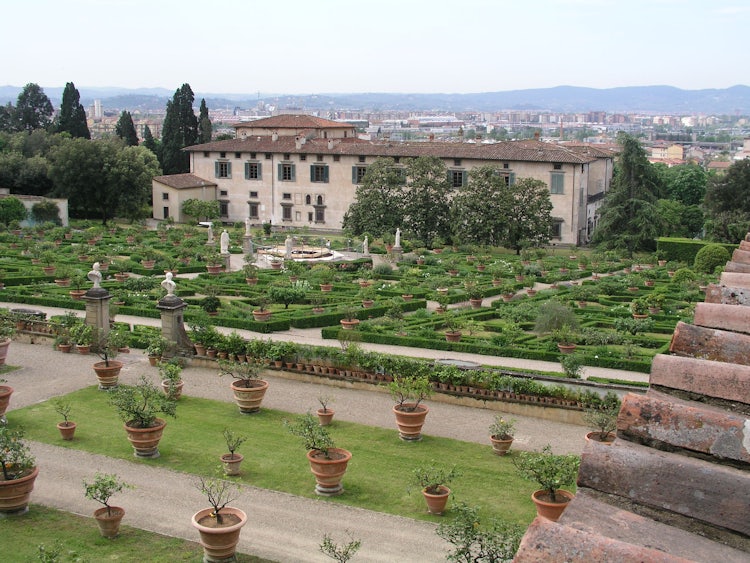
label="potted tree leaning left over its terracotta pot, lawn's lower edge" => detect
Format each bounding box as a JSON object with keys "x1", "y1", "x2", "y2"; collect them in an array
[{"x1": 284, "y1": 412, "x2": 352, "y2": 496}]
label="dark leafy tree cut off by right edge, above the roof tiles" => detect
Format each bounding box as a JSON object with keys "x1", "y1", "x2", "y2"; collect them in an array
[{"x1": 704, "y1": 159, "x2": 750, "y2": 243}]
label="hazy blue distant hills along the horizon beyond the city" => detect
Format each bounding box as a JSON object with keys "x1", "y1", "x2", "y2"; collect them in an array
[{"x1": 0, "y1": 85, "x2": 750, "y2": 115}]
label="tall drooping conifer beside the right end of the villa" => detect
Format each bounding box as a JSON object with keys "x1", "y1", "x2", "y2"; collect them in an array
[{"x1": 592, "y1": 134, "x2": 660, "y2": 256}]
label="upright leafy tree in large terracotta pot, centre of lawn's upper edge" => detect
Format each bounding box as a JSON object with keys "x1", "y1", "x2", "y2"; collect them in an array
[{"x1": 389, "y1": 372, "x2": 433, "y2": 442}]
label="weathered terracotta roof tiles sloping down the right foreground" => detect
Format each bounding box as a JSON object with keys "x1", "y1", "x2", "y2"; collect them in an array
[{"x1": 515, "y1": 239, "x2": 750, "y2": 563}]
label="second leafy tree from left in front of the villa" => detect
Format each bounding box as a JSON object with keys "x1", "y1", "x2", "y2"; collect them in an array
[{"x1": 402, "y1": 156, "x2": 452, "y2": 242}]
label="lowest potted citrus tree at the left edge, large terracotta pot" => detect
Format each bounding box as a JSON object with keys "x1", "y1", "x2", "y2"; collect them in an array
[{"x1": 0, "y1": 426, "x2": 39, "y2": 514}]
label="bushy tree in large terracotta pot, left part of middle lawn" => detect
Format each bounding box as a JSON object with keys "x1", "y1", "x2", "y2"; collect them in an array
[{"x1": 109, "y1": 376, "x2": 177, "y2": 458}]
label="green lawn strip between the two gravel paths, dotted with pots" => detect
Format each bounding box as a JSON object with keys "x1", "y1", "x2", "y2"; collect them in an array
[{"x1": 12, "y1": 387, "x2": 536, "y2": 525}]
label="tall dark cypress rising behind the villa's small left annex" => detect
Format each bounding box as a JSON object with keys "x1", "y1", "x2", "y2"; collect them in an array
[{"x1": 161, "y1": 84, "x2": 198, "y2": 174}]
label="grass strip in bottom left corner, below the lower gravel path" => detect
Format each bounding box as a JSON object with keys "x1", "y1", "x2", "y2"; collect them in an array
[{"x1": 0, "y1": 504, "x2": 269, "y2": 563}]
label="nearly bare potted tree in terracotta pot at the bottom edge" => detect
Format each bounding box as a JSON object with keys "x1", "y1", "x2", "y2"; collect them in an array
[{"x1": 192, "y1": 477, "x2": 247, "y2": 561}]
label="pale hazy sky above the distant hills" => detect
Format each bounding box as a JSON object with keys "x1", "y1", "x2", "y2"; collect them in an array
[{"x1": 0, "y1": 0, "x2": 750, "y2": 94}]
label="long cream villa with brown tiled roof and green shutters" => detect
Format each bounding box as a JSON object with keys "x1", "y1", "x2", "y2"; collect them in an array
[{"x1": 152, "y1": 115, "x2": 614, "y2": 244}]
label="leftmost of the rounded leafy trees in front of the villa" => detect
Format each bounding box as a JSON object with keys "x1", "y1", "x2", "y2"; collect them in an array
[{"x1": 343, "y1": 158, "x2": 404, "y2": 236}]
